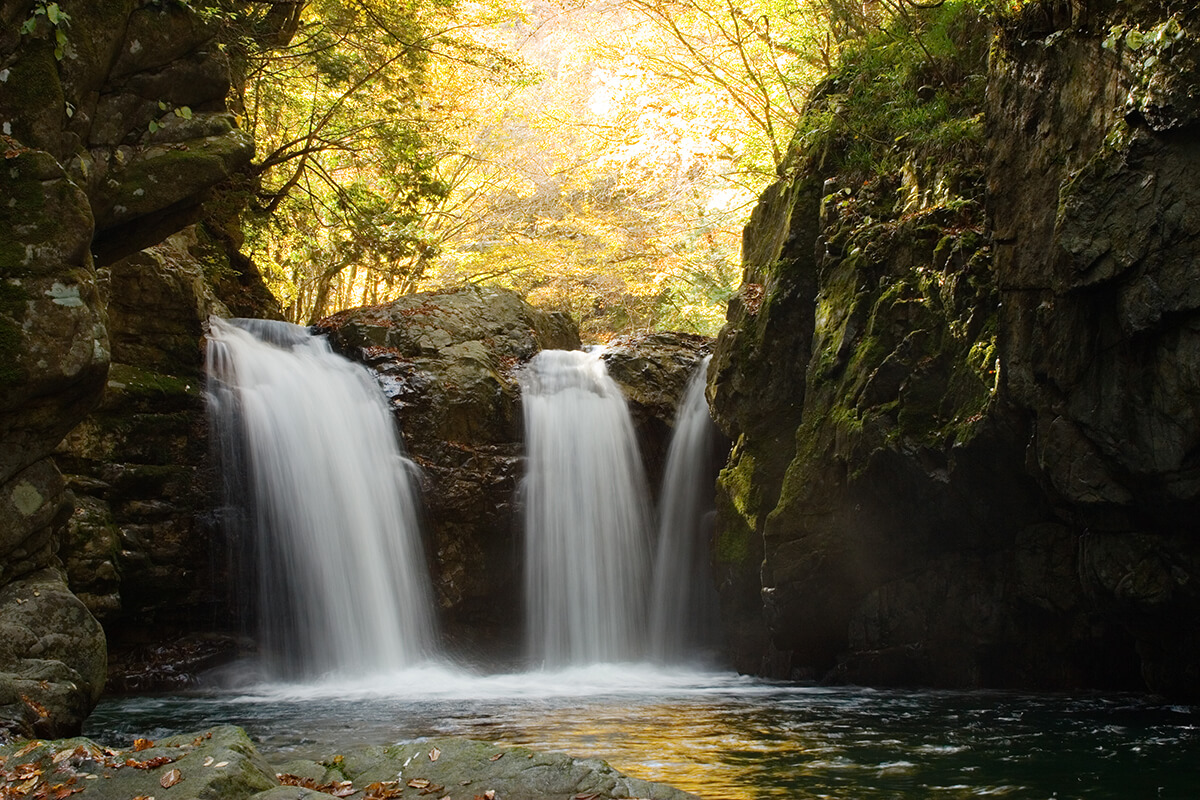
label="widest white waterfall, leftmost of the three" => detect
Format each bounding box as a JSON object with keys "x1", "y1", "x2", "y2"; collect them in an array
[{"x1": 208, "y1": 318, "x2": 433, "y2": 678}]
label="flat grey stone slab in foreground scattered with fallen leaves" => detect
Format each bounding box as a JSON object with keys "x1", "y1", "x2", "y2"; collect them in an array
[{"x1": 0, "y1": 726, "x2": 695, "y2": 800}]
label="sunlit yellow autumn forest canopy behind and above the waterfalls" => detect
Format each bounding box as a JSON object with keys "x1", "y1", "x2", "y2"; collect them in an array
[{"x1": 216, "y1": 0, "x2": 1022, "y2": 341}]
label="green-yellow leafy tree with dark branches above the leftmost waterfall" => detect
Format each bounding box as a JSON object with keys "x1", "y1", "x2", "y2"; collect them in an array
[{"x1": 214, "y1": 0, "x2": 516, "y2": 323}]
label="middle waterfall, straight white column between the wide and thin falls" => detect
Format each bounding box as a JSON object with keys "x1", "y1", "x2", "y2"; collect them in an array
[{"x1": 521, "y1": 350, "x2": 649, "y2": 667}]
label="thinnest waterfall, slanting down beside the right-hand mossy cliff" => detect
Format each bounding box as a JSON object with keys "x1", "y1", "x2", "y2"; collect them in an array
[{"x1": 650, "y1": 357, "x2": 718, "y2": 662}]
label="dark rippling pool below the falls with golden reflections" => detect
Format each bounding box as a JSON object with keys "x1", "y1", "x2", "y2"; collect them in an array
[{"x1": 85, "y1": 666, "x2": 1200, "y2": 800}]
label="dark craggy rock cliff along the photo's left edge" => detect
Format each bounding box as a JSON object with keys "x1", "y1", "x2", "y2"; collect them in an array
[{"x1": 0, "y1": 0, "x2": 261, "y2": 735}]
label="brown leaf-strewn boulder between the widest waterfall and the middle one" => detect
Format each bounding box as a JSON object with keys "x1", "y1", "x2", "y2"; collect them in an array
[{"x1": 317, "y1": 287, "x2": 580, "y2": 654}]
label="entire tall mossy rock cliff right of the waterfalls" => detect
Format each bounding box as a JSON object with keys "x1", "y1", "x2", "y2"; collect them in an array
[{"x1": 709, "y1": 2, "x2": 1200, "y2": 697}]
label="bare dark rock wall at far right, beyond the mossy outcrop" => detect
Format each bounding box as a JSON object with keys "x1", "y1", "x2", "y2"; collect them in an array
[{"x1": 988, "y1": 4, "x2": 1200, "y2": 698}]
